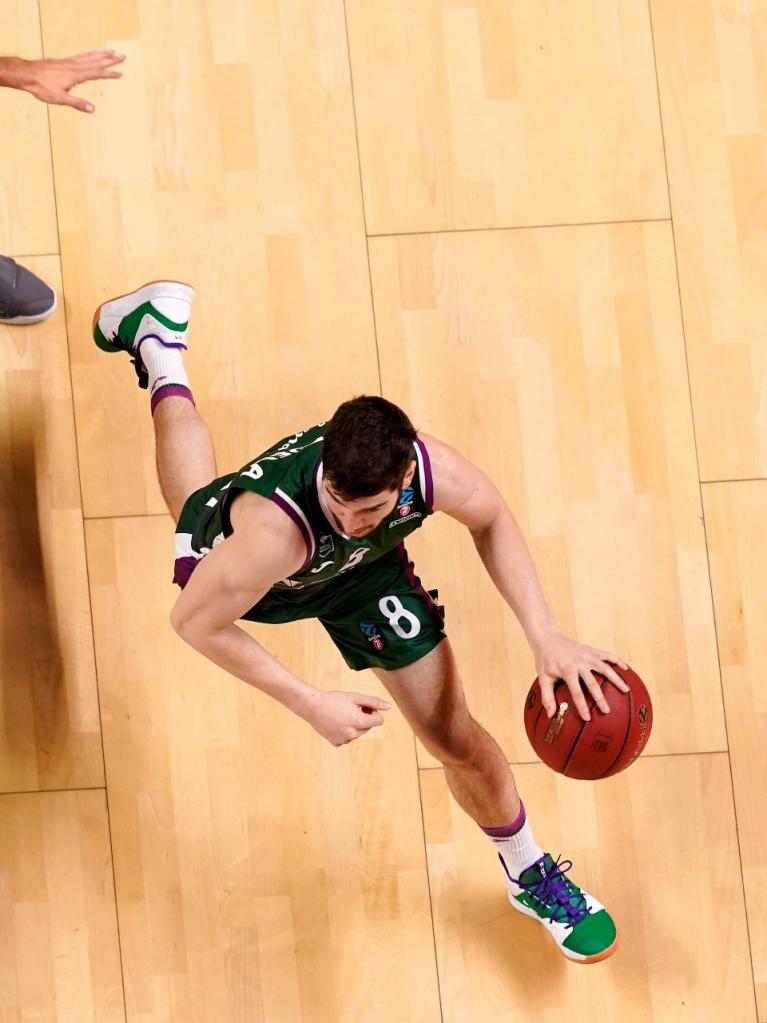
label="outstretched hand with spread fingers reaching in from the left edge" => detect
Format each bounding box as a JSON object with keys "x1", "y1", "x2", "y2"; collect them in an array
[{"x1": 5, "y1": 50, "x2": 125, "y2": 114}]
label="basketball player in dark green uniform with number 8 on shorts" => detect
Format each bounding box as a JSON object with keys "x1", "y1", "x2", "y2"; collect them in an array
[{"x1": 93, "y1": 281, "x2": 627, "y2": 963}]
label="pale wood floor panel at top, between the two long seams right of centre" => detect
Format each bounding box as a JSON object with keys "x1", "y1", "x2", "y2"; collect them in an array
[{"x1": 347, "y1": 0, "x2": 669, "y2": 234}]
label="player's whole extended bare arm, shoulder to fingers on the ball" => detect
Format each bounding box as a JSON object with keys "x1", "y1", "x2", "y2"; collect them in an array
[{"x1": 421, "y1": 435, "x2": 628, "y2": 717}]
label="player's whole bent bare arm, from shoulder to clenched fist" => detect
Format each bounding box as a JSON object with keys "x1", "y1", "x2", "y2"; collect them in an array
[{"x1": 171, "y1": 494, "x2": 390, "y2": 746}]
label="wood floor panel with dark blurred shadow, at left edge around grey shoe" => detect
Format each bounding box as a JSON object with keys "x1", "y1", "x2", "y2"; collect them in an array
[{"x1": 0, "y1": 256, "x2": 103, "y2": 792}]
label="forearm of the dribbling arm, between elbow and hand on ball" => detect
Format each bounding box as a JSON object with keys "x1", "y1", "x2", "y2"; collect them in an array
[{"x1": 471, "y1": 507, "x2": 557, "y2": 647}]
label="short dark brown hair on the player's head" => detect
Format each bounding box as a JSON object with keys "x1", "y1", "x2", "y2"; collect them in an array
[{"x1": 322, "y1": 394, "x2": 416, "y2": 500}]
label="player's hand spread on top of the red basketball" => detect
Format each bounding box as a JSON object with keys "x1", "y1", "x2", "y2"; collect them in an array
[{"x1": 533, "y1": 632, "x2": 629, "y2": 721}]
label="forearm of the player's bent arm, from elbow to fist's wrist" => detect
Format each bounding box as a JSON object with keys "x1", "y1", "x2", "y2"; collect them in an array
[{"x1": 173, "y1": 621, "x2": 319, "y2": 717}]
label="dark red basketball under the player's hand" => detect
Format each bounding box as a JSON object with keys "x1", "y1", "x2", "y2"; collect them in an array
[{"x1": 525, "y1": 665, "x2": 652, "y2": 782}]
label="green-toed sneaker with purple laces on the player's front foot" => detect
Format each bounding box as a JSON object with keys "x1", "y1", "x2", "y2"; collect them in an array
[{"x1": 499, "y1": 852, "x2": 618, "y2": 963}]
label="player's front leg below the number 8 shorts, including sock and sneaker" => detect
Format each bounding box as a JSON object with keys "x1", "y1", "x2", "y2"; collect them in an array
[{"x1": 375, "y1": 639, "x2": 618, "y2": 963}]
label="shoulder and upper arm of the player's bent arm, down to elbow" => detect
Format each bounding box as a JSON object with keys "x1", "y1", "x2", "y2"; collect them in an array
[{"x1": 171, "y1": 495, "x2": 306, "y2": 635}]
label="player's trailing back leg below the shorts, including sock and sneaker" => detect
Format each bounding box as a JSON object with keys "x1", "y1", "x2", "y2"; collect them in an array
[{"x1": 93, "y1": 280, "x2": 216, "y2": 521}]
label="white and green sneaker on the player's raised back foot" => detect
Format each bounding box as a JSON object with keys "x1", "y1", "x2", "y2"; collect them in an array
[{"x1": 93, "y1": 280, "x2": 194, "y2": 388}]
